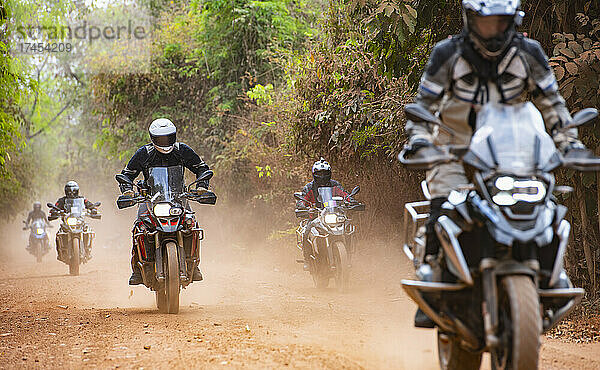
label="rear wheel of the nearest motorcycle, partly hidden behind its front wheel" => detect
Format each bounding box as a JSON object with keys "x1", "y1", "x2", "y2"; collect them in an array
[{"x1": 438, "y1": 332, "x2": 481, "y2": 370}]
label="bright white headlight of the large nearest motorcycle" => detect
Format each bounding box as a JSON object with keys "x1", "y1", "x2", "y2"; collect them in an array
[{"x1": 491, "y1": 176, "x2": 546, "y2": 206}]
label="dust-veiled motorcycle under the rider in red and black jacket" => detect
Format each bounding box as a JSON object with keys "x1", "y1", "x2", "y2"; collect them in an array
[{"x1": 294, "y1": 186, "x2": 365, "y2": 291}]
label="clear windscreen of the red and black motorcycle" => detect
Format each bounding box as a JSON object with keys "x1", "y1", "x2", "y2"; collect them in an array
[{"x1": 148, "y1": 166, "x2": 184, "y2": 202}]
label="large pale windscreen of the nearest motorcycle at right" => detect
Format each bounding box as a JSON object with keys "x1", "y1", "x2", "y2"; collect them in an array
[{"x1": 469, "y1": 102, "x2": 556, "y2": 175}]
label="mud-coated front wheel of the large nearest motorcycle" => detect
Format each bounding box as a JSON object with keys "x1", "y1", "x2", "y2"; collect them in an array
[{"x1": 491, "y1": 275, "x2": 542, "y2": 370}]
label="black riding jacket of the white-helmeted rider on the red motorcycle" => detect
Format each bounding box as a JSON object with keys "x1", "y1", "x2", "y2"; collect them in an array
[{"x1": 119, "y1": 143, "x2": 209, "y2": 192}]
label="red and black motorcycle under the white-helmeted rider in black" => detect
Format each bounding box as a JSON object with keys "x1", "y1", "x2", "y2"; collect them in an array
[{"x1": 116, "y1": 166, "x2": 217, "y2": 313}]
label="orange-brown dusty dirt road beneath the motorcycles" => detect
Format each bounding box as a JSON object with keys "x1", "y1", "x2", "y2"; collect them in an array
[{"x1": 0, "y1": 231, "x2": 600, "y2": 369}]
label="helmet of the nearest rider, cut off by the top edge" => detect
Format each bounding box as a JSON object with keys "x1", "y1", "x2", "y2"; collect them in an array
[{"x1": 462, "y1": 0, "x2": 525, "y2": 59}]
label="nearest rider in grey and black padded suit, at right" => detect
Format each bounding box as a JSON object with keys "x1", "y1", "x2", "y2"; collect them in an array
[{"x1": 406, "y1": 0, "x2": 591, "y2": 327}]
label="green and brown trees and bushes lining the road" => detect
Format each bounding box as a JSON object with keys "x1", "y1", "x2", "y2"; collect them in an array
[{"x1": 0, "y1": 0, "x2": 600, "y2": 304}]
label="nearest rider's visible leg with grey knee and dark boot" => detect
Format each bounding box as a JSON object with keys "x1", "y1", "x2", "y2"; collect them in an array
[{"x1": 415, "y1": 162, "x2": 469, "y2": 328}]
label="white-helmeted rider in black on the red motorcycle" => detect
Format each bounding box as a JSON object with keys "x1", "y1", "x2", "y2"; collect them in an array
[{"x1": 119, "y1": 118, "x2": 209, "y2": 285}]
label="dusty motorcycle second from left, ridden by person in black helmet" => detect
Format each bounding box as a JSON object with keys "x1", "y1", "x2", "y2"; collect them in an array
[{"x1": 47, "y1": 198, "x2": 102, "y2": 276}]
